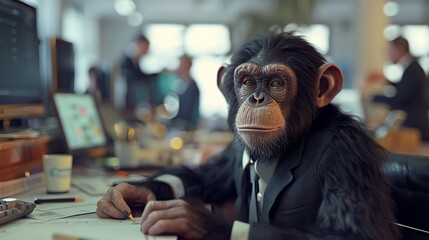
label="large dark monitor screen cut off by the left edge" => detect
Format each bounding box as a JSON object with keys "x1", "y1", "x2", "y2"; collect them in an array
[{"x1": 0, "y1": 0, "x2": 45, "y2": 120}]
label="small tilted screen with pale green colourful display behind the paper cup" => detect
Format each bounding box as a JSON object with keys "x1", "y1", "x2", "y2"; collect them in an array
[{"x1": 53, "y1": 93, "x2": 108, "y2": 153}]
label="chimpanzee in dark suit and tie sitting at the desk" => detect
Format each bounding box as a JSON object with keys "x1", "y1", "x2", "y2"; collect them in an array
[{"x1": 97, "y1": 31, "x2": 400, "y2": 239}]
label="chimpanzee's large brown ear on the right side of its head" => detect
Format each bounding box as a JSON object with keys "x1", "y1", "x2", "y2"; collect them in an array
[{"x1": 316, "y1": 63, "x2": 343, "y2": 108}]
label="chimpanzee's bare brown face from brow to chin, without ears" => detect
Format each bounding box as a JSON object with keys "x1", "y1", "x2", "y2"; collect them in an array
[{"x1": 234, "y1": 63, "x2": 297, "y2": 152}]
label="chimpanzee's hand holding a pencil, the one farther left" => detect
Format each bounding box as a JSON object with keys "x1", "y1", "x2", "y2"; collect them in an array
[{"x1": 96, "y1": 183, "x2": 156, "y2": 219}]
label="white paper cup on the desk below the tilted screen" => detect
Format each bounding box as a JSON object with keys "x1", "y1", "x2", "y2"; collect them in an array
[{"x1": 43, "y1": 154, "x2": 73, "y2": 193}]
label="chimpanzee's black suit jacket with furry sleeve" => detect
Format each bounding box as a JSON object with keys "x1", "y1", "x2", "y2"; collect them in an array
[{"x1": 159, "y1": 106, "x2": 396, "y2": 239}]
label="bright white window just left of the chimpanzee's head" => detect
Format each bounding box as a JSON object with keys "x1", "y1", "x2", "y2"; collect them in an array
[{"x1": 141, "y1": 24, "x2": 231, "y2": 118}]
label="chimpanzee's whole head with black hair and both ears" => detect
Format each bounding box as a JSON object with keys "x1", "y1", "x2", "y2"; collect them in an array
[{"x1": 217, "y1": 32, "x2": 343, "y2": 160}]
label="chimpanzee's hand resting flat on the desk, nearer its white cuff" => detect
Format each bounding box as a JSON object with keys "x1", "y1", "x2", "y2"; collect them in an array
[{"x1": 141, "y1": 199, "x2": 232, "y2": 240}]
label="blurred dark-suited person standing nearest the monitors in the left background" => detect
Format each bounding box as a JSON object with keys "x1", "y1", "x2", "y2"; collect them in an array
[{"x1": 121, "y1": 35, "x2": 157, "y2": 118}]
